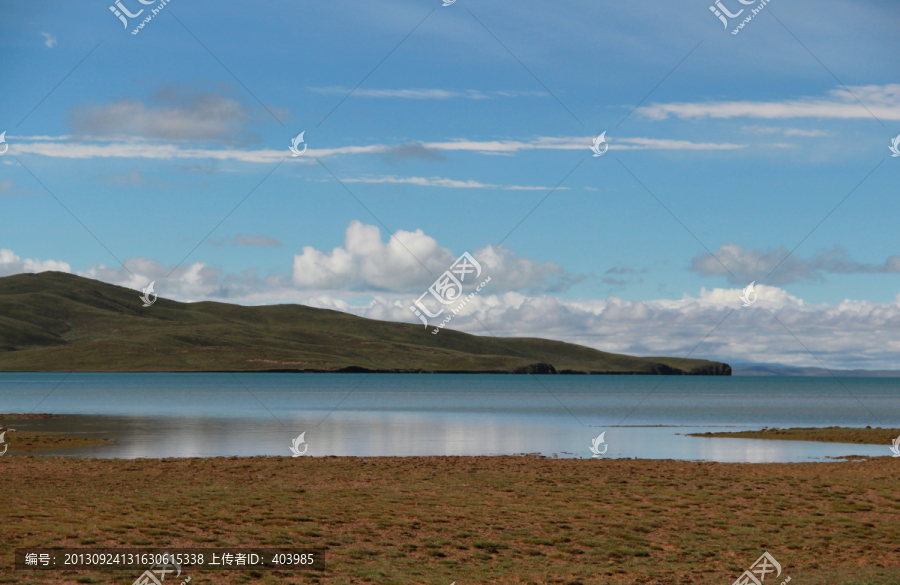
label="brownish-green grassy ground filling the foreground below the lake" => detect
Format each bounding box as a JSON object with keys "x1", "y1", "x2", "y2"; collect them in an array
[{"x1": 0, "y1": 455, "x2": 900, "y2": 585}]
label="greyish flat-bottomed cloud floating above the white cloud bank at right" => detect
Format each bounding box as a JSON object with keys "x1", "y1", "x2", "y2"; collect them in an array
[{"x1": 690, "y1": 243, "x2": 900, "y2": 285}]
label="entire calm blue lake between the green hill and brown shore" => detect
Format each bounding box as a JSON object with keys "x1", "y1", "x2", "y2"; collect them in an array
[{"x1": 0, "y1": 373, "x2": 900, "y2": 462}]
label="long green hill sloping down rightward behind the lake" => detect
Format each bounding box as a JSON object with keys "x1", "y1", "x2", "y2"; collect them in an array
[{"x1": 0, "y1": 272, "x2": 731, "y2": 375}]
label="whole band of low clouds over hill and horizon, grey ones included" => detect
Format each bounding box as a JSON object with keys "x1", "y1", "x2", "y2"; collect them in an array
[{"x1": 0, "y1": 221, "x2": 900, "y2": 369}]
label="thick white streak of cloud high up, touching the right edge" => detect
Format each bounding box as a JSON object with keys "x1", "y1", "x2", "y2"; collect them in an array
[{"x1": 638, "y1": 84, "x2": 900, "y2": 120}]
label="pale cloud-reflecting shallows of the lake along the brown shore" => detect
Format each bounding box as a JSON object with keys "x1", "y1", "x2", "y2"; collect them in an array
[{"x1": 7, "y1": 413, "x2": 889, "y2": 463}]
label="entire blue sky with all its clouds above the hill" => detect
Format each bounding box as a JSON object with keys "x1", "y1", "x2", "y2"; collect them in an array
[{"x1": 0, "y1": 0, "x2": 900, "y2": 369}]
